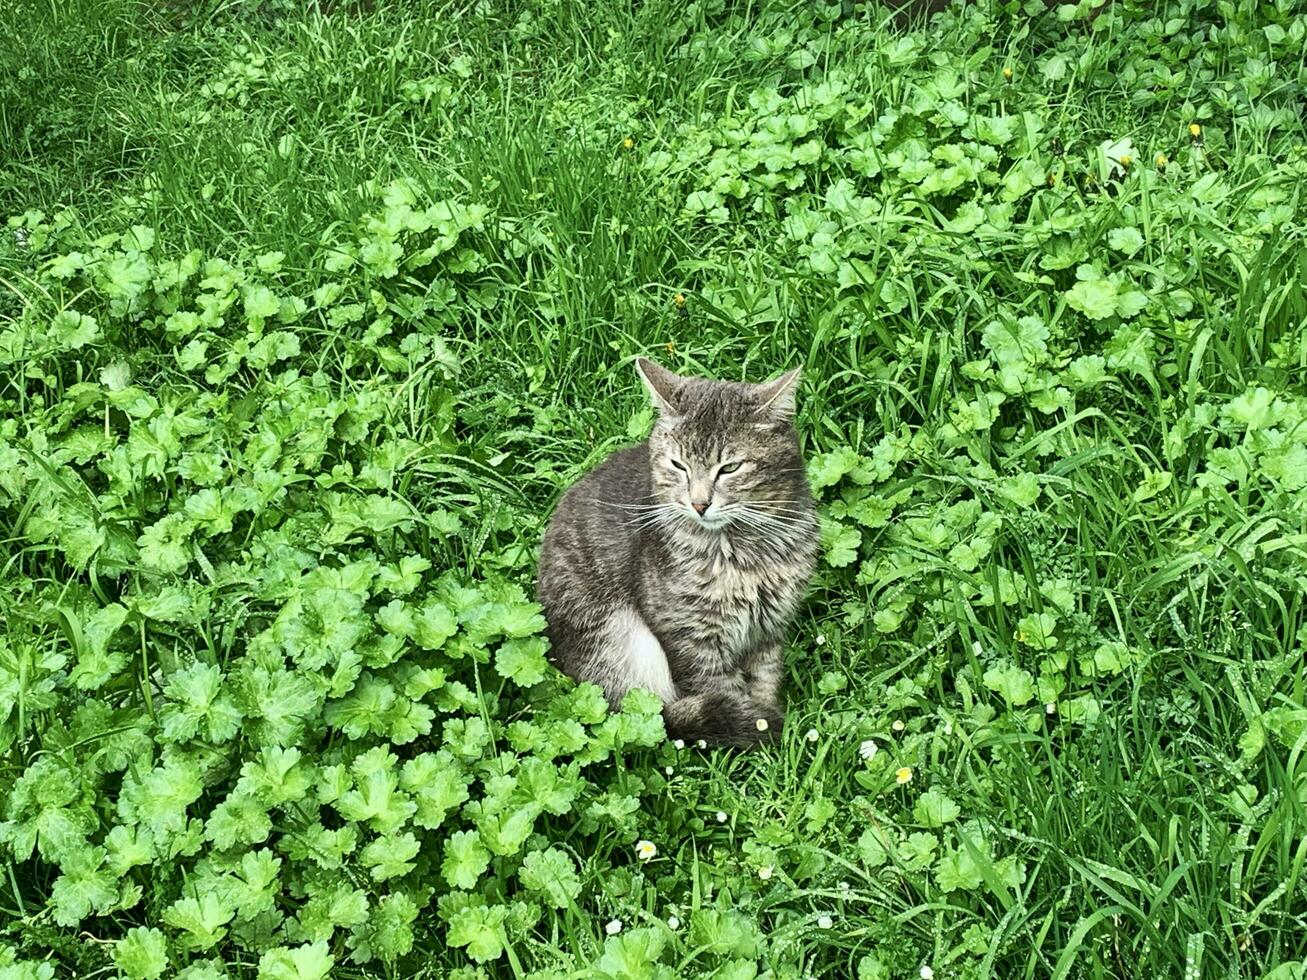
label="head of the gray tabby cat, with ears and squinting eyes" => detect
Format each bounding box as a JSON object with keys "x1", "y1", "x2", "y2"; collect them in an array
[{"x1": 635, "y1": 358, "x2": 810, "y2": 531}]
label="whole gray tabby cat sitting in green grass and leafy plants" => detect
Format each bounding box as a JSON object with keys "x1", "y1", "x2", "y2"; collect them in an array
[{"x1": 538, "y1": 358, "x2": 818, "y2": 745}]
